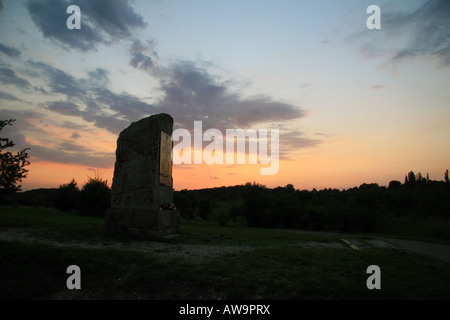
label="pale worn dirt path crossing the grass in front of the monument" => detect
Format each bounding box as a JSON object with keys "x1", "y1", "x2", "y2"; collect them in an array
[{"x1": 0, "y1": 228, "x2": 450, "y2": 263}]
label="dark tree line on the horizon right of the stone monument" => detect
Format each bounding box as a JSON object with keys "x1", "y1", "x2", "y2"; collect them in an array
[{"x1": 174, "y1": 170, "x2": 450, "y2": 232}]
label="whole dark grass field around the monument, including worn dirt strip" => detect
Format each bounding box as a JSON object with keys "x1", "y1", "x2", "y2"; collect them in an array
[{"x1": 0, "y1": 207, "x2": 450, "y2": 300}]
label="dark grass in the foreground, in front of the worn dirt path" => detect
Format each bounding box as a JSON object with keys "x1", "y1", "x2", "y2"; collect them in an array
[{"x1": 0, "y1": 242, "x2": 450, "y2": 300}]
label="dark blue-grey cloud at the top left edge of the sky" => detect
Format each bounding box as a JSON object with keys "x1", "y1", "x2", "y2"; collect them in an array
[{"x1": 27, "y1": 0, "x2": 146, "y2": 51}]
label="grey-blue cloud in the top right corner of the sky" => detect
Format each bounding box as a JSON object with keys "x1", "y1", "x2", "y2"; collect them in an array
[{"x1": 347, "y1": 0, "x2": 450, "y2": 66}]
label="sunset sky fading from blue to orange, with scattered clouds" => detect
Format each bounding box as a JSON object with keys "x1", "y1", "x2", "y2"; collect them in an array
[{"x1": 0, "y1": 0, "x2": 450, "y2": 190}]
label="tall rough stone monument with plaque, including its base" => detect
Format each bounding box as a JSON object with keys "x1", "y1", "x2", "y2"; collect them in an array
[{"x1": 106, "y1": 113, "x2": 180, "y2": 235}]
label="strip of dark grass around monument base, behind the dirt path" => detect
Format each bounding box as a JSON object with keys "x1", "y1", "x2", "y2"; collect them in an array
[{"x1": 0, "y1": 206, "x2": 339, "y2": 245}]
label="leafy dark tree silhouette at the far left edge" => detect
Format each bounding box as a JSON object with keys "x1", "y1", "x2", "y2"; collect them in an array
[{"x1": 0, "y1": 119, "x2": 30, "y2": 194}]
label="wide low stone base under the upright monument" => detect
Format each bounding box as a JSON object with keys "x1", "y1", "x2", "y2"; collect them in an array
[{"x1": 105, "y1": 208, "x2": 180, "y2": 236}]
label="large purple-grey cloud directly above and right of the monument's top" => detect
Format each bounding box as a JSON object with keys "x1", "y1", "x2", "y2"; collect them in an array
[{"x1": 156, "y1": 61, "x2": 304, "y2": 130}]
